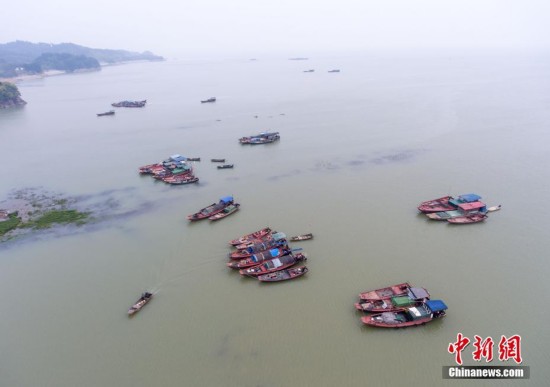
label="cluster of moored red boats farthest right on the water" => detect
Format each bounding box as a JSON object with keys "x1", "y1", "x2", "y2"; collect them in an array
[{"x1": 418, "y1": 193, "x2": 501, "y2": 224}]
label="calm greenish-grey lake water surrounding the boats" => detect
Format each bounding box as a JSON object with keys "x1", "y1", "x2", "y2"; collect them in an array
[{"x1": 0, "y1": 53, "x2": 550, "y2": 387}]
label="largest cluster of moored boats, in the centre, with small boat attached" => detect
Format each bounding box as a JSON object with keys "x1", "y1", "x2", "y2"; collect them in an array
[{"x1": 227, "y1": 227, "x2": 313, "y2": 282}]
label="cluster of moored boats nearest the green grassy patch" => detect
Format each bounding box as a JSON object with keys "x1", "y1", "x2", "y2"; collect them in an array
[{"x1": 139, "y1": 154, "x2": 199, "y2": 185}]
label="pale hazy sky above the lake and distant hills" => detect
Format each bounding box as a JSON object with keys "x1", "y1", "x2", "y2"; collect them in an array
[{"x1": 0, "y1": 0, "x2": 550, "y2": 57}]
